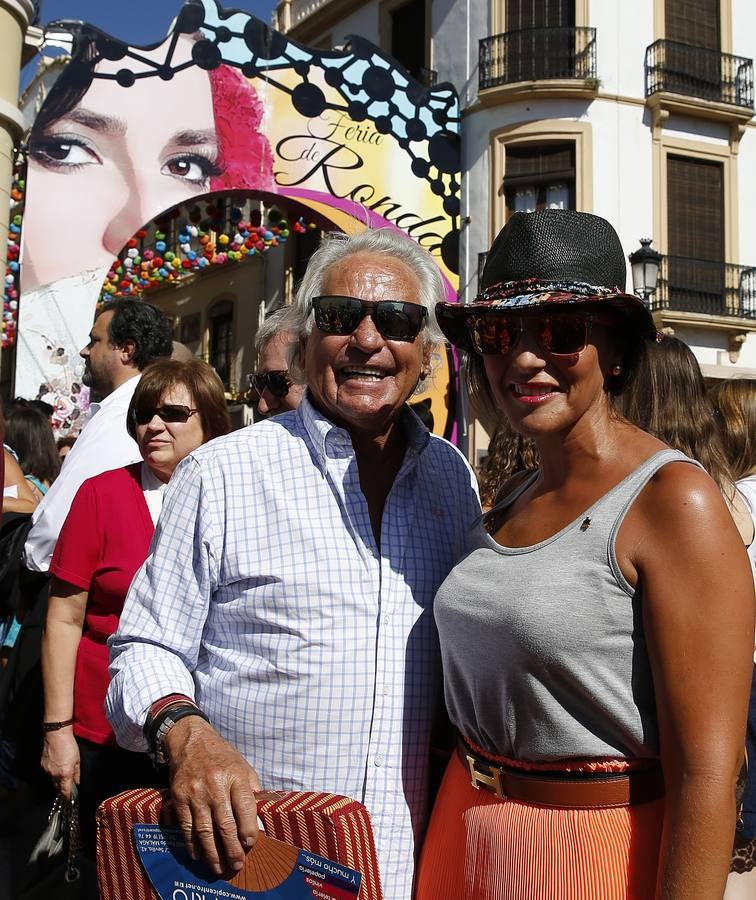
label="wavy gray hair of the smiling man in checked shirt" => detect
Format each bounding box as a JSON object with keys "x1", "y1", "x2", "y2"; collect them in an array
[{"x1": 284, "y1": 228, "x2": 445, "y2": 383}]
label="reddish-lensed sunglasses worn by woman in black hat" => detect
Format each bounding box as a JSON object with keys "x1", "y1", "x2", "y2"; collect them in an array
[{"x1": 467, "y1": 311, "x2": 615, "y2": 356}]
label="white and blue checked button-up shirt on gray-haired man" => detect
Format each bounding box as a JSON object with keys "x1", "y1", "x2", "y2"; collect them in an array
[{"x1": 107, "y1": 398, "x2": 480, "y2": 900}]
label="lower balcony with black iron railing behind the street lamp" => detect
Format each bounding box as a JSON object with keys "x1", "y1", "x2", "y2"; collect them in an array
[{"x1": 649, "y1": 256, "x2": 756, "y2": 329}]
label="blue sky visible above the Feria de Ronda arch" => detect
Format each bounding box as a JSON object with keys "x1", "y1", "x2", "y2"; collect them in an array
[{"x1": 40, "y1": 0, "x2": 276, "y2": 45}]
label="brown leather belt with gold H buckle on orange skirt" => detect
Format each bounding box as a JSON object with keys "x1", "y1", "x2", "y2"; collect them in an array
[{"x1": 457, "y1": 740, "x2": 664, "y2": 809}]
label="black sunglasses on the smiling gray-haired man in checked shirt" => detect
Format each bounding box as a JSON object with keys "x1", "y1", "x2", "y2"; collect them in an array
[{"x1": 312, "y1": 296, "x2": 428, "y2": 342}]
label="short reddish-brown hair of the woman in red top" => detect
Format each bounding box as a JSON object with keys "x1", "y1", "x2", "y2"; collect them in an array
[{"x1": 126, "y1": 359, "x2": 231, "y2": 441}]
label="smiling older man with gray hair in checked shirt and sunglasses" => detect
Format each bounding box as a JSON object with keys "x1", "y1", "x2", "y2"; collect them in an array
[{"x1": 107, "y1": 231, "x2": 479, "y2": 900}]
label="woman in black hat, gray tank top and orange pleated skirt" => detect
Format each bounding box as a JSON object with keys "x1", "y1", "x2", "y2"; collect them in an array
[{"x1": 418, "y1": 210, "x2": 754, "y2": 900}]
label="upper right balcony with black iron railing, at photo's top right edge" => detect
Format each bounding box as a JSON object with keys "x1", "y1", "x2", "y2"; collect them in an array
[{"x1": 645, "y1": 40, "x2": 754, "y2": 133}]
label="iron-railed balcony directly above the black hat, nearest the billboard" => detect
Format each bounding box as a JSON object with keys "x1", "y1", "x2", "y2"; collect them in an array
[{"x1": 478, "y1": 28, "x2": 598, "y2": 93}]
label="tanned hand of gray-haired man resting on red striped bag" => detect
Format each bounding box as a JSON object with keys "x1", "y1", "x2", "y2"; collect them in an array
[{"x1": 163, "y1": 716, "x2": 261, "y2": 875}]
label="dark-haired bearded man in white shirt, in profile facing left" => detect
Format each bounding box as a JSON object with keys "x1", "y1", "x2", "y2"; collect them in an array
[{"x1": 24, "y1": 300, "x2": 173, "y2": 572}]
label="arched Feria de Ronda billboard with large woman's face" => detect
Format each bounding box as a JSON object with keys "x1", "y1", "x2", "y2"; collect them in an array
[{"x1": 16, "y1": 0, "x2": 460, "y2": 432}]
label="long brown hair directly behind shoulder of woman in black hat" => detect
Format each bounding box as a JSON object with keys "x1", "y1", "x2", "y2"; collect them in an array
[{"x1": 619, "y1": 337, "x2": 733, "y2": 498}]
